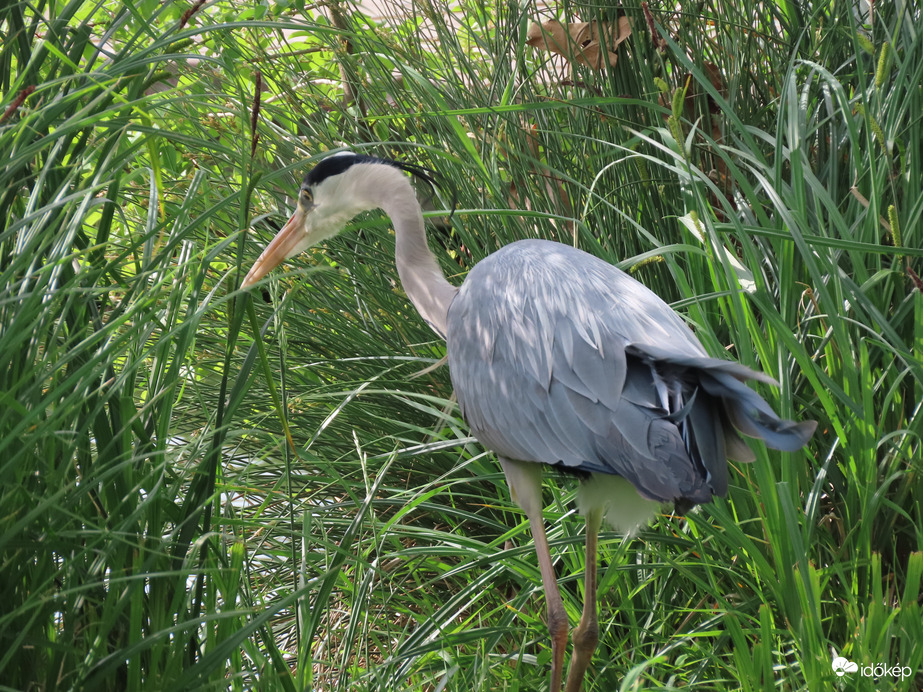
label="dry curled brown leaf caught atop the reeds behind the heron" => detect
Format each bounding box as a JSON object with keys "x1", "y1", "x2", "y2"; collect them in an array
[{"x1": 526, "y1": 16, "x2": 631, "y2": 70}]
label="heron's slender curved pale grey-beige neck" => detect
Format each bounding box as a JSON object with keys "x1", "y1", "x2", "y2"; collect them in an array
[{"x1": 364, "y1": 166, "x2": 458, "y2": 338}]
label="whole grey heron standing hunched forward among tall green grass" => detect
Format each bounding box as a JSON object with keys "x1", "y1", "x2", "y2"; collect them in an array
[{"x1": 242, "y1": 152, "x2": 817, "y2": 692}]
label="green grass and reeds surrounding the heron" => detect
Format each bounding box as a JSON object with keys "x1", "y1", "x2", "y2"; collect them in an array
[{"x1": 0, "y1": 0, "x2": 923, "y2": 691}]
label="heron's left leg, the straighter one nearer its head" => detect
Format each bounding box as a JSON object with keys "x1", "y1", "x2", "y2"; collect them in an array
[{"x1": 500, "y1": 458, "x2": 570, "y2": 692}]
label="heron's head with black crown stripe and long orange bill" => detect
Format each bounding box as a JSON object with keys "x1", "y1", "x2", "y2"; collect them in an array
[{"x1": 241, "y1": 151, "x2": 392, "y2": 288}]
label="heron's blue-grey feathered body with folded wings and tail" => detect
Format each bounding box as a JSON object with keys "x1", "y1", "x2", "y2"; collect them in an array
[{"x1": 447, "y1": 241, "x2": 814, "y2": 503}]
